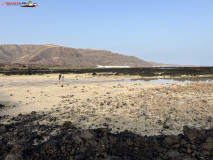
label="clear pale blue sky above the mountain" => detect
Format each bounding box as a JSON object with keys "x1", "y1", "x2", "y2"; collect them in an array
[{"x1": 0, "y1": 0, "x2": 213, "y2": 66}]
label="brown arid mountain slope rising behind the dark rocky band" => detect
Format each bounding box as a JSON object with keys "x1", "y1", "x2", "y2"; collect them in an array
[{"x1": 0, "y1": 45, "x2": 152, "y2": 67}]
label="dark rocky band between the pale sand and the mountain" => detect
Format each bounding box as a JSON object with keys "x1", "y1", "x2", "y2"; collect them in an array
[{"x1": 0, "y1": 63, "x2": 213, "y2": 77}]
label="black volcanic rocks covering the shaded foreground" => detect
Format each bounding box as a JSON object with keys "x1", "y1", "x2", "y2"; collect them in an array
[{"x1": 0, "y1": 112, "x2": 213, "y2": 160}]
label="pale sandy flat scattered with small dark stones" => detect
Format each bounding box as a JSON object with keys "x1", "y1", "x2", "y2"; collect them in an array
[{"x1": 0, "y1": 74, "x2": 213, "y2": 135}]
